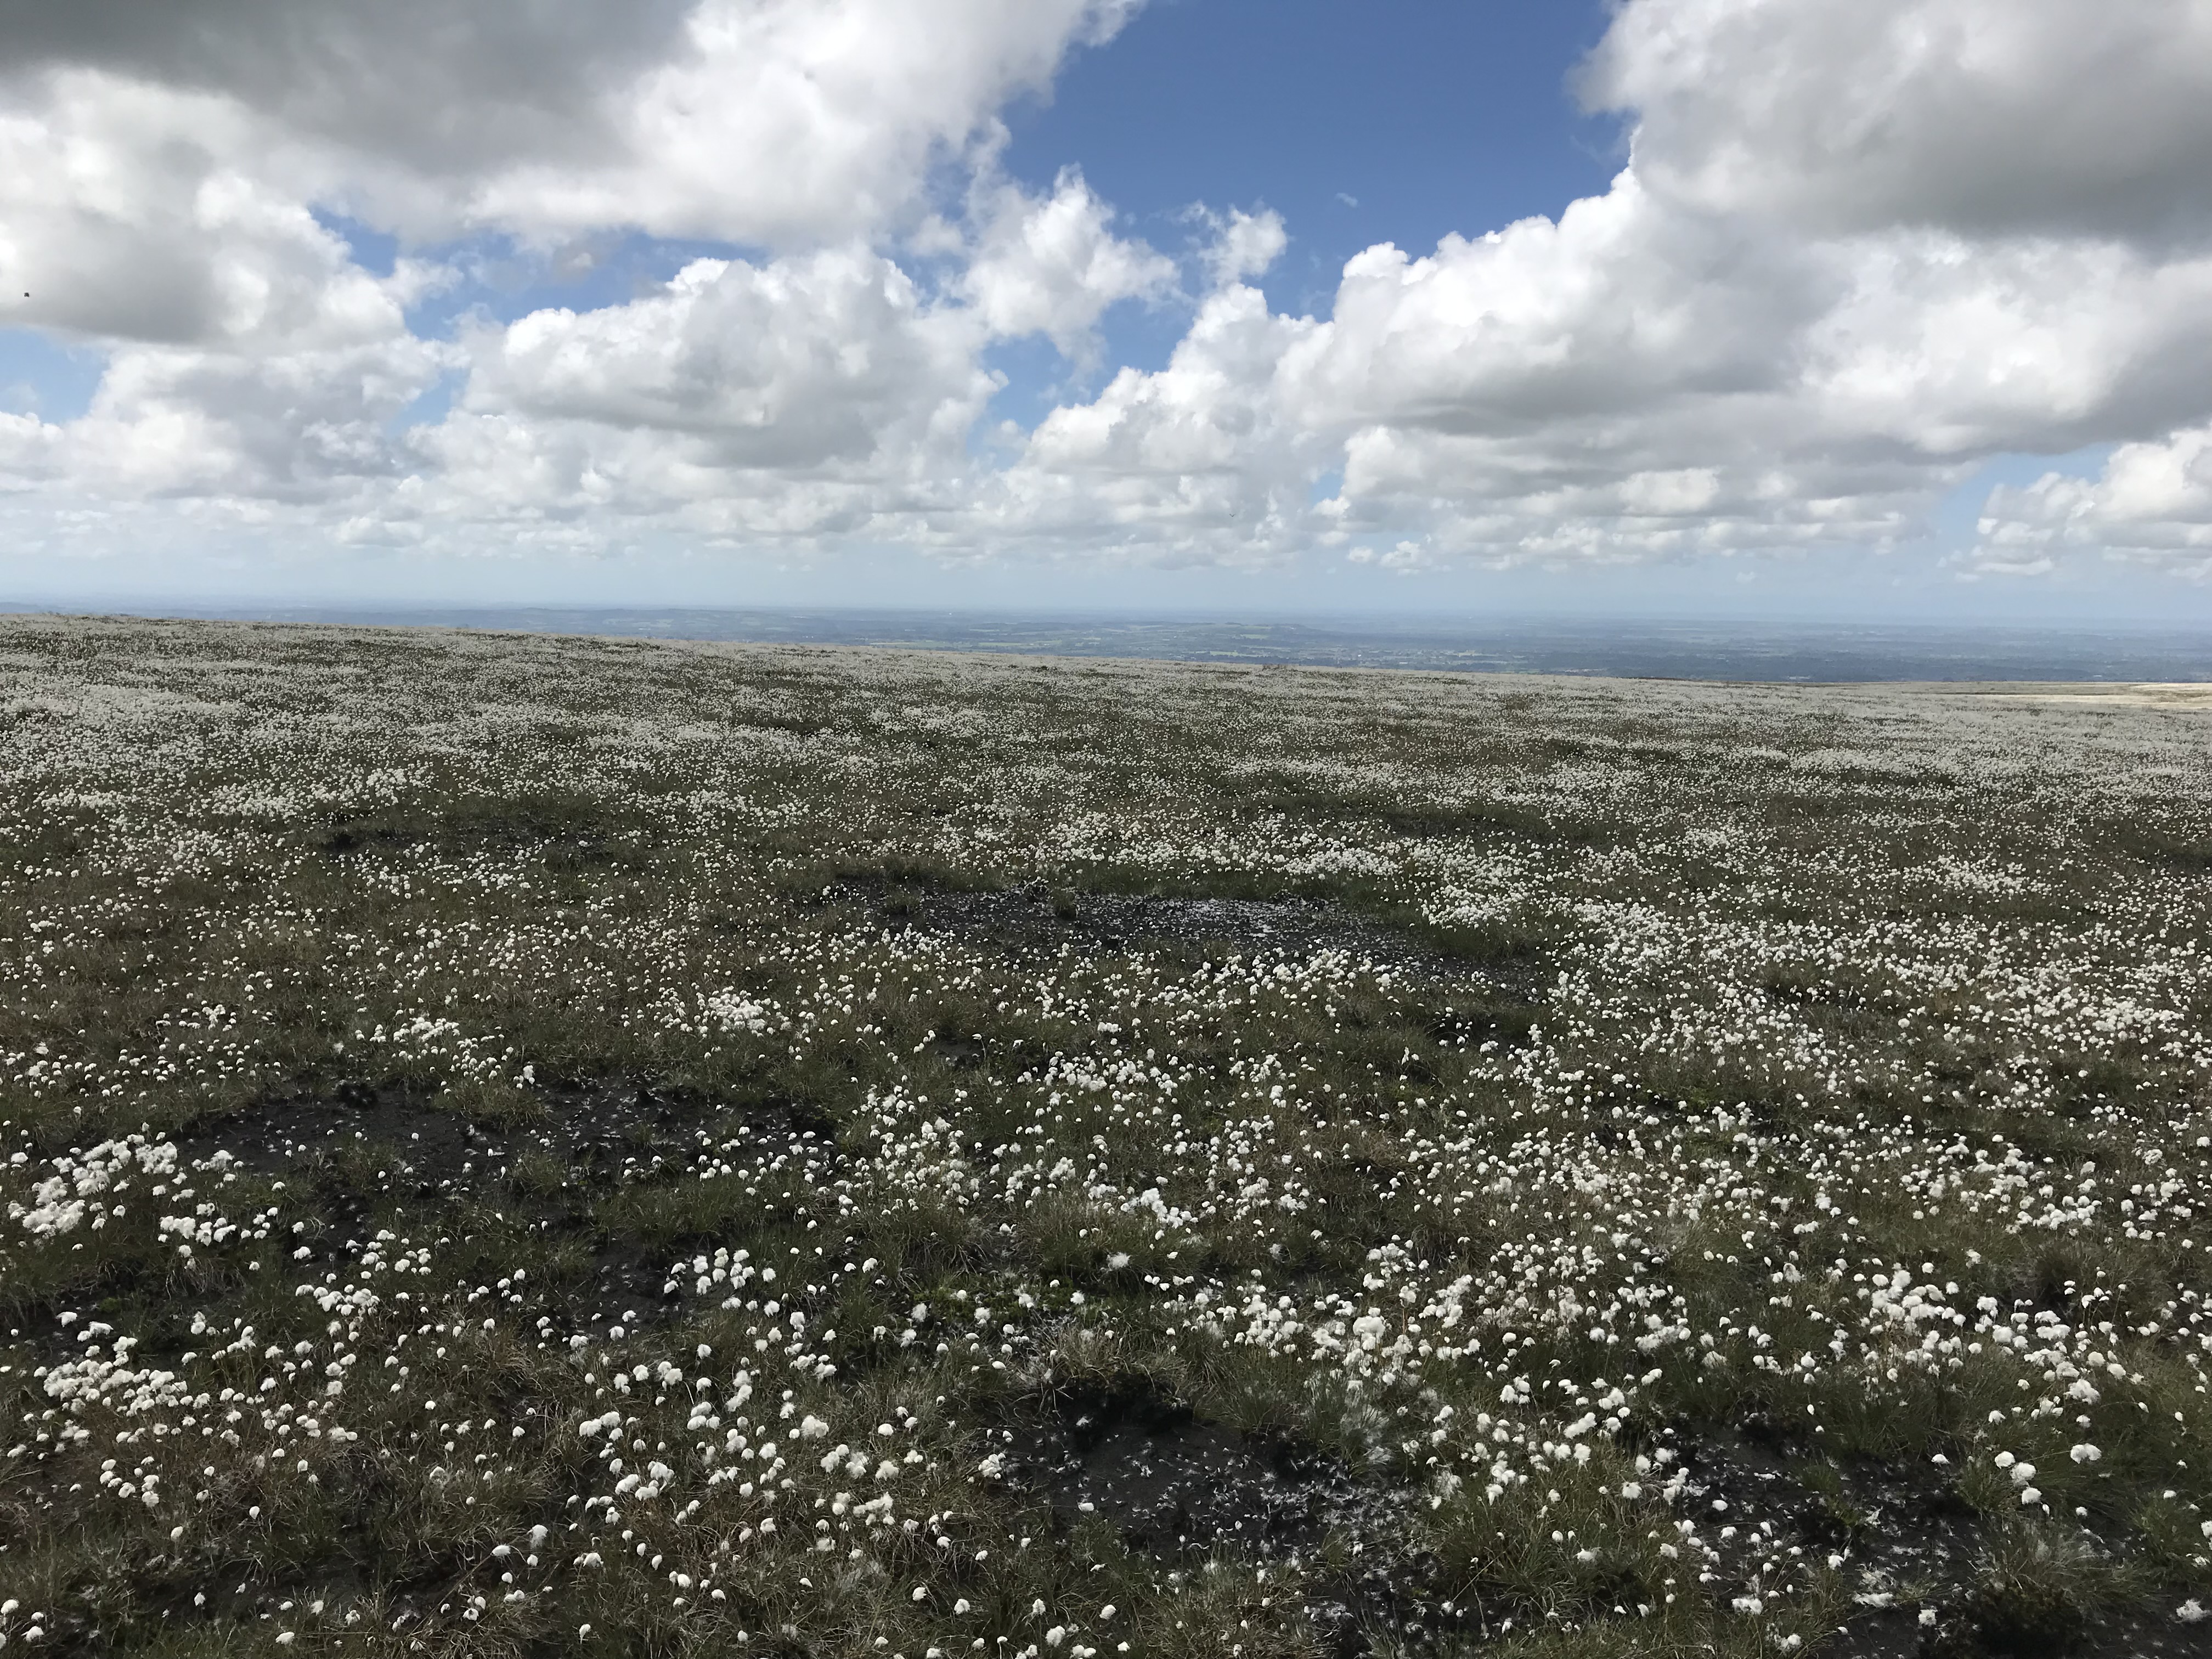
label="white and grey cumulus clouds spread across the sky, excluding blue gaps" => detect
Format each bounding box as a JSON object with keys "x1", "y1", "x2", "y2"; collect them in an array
[{"x1": 0, "y1": 0, "x2": 2212, "y2": 573}]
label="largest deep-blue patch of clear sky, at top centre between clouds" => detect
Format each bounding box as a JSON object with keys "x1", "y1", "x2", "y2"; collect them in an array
[{"x1": 1007, "y1": 0, "x2": 1621, "y2": 312}]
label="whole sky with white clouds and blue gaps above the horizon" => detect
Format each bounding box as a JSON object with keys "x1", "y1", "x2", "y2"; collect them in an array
[{"x1": 0, "y1": 0, "x2": 2212, "y2": 622}]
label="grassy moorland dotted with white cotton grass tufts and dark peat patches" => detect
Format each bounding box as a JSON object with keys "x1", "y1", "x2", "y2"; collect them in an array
[{"x1": 0, "y1": 617, "x2": 2212, "y2": 1659}]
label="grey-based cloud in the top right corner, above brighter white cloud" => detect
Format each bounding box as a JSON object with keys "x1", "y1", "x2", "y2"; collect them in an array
[{"x1": 1582, "y1": 0, "x2": 2212, "y2": 236}]
